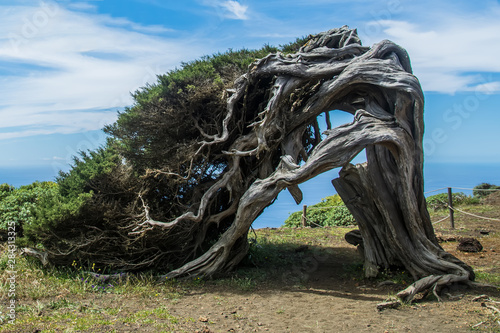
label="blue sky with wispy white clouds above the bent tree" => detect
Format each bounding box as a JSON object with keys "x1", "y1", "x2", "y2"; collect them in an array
[{"x1": 0, "y1": 0, "x2": 500, "y2": 170}]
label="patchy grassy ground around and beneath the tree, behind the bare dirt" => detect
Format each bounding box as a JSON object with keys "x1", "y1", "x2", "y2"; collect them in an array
[{"x1": 0, "y1": 196, "x2": 500, "y2": 332}]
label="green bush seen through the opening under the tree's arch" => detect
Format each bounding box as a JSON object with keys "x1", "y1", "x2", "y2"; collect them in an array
[{"x1": 284, "y1": 194, "x2": 356, "y2": 228}]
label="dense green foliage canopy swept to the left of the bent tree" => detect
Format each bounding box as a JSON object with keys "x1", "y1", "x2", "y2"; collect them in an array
[{"x1": 27, "y1": 39, "x2": 307, "y2": 270}]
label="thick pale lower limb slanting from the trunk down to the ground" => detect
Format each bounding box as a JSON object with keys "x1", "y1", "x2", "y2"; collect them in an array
[{"x1": 168, "y1": 111, "x2": 412, "y2": 277}]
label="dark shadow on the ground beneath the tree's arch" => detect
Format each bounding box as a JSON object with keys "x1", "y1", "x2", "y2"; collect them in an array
[{"x1": 207, "y1": 236, "x2": 412, "y2": 301}]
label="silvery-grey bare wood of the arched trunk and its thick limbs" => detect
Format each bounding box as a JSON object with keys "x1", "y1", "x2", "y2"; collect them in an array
[{"x1": 159, "y1": 27, "x2": 474, "y2": 300}]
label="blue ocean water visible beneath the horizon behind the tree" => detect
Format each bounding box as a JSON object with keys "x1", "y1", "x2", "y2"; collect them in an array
[{"x1": 0, "y1": 163, "x2": 500, "y2": 229}]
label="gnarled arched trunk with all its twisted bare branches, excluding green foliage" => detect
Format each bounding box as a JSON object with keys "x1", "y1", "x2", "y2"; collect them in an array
[{"x1": 29, "y1": 27, "x2": 474, "y2": 299}]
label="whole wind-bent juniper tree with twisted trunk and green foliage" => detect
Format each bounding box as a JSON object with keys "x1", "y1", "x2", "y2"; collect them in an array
[{"x1": 29, "y1": 27, "x2": 474, "y2": 299}]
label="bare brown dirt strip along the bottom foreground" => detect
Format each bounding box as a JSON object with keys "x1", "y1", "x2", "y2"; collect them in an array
[{"x1": 74, "y1": 281, "x2": 494, "y2": 332}]
